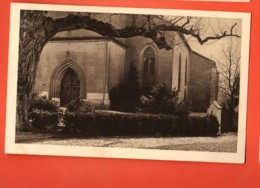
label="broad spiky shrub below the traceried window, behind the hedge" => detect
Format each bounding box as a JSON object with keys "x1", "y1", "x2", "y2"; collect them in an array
[{"x1": 139, "y1": 82, "x2": 190, "y2": 116}]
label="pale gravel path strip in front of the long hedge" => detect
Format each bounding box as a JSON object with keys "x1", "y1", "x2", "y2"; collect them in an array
[{"x1": 16, "y1": 133, "x2": 237, "y2": 152}]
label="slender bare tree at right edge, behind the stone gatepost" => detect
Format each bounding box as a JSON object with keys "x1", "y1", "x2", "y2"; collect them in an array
[{"x1": 218, "y1": 39, "x2": 240, "y2": 130}]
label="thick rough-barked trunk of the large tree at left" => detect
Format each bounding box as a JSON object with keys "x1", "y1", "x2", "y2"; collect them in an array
[{"x1": 16, "y1": 11, "x2": 54, "y2": 131}]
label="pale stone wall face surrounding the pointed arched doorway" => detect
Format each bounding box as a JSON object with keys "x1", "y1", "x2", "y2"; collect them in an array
[{"x1": 35, "y1": 40, "x2": 110, "y2": 98}]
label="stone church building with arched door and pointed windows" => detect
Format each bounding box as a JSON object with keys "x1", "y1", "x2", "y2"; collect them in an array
[{"x1": 35, "y1": 14, "x2": 218, "y2": 112}]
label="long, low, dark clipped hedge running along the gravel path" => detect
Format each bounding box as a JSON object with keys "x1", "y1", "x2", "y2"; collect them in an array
[{"x1": 64, "y1": 111, "x2": 219, "y2": 136}]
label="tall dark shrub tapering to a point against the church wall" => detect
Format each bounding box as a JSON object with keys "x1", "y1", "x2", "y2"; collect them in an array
[{"x1": 109, "y1": 63, "x2": 141, "y2": 112}]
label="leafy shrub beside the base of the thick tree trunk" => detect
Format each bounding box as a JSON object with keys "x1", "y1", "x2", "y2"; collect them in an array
[{"x1": 29, "y1": 94, "x2": 58, "y2": 129}]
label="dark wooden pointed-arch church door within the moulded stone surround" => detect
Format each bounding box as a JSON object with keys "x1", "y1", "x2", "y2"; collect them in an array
[{"x1": 60, "y1": 68, "x2": 80, "y2": 106}]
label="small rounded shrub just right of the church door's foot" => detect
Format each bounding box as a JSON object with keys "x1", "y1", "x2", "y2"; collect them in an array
[{"x1": 67, "y1": 97, "x2": 95, "y2": 113}]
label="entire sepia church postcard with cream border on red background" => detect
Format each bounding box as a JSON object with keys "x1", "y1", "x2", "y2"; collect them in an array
[{"x1": 5, "y1": 3, "x2": 250, "y2": 163}]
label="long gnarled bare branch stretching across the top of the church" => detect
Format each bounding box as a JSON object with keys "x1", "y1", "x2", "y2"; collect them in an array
[{"x1": 42, "y1": 14, "x2": 240, "y2": 49}]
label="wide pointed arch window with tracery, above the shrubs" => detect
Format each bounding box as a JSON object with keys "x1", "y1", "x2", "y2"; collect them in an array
[{"x1": 143, "y1": 47, "x2": 155, "y2": 85}]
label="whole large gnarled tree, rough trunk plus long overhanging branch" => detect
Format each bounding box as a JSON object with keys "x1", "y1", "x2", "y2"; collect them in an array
[{"x1": 17, "y1": 10, "x2": 240, "y2": 130}]
